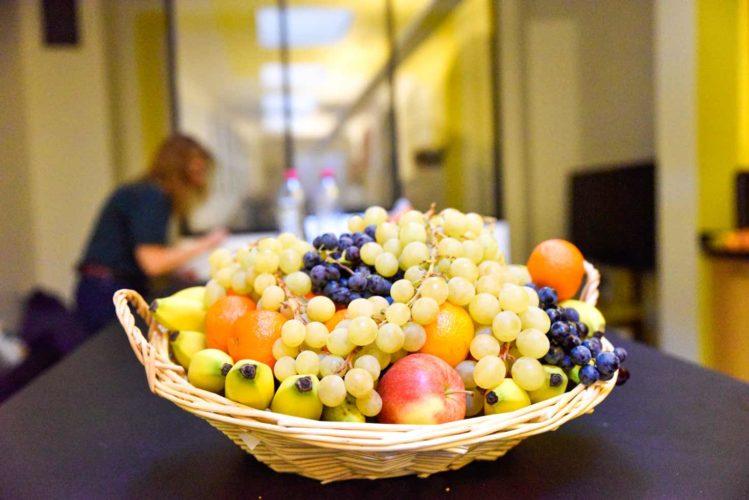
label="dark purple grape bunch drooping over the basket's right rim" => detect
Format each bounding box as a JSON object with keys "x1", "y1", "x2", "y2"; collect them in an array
[{"x1": 538, "y1": 287, "x2": 629, "y2": 386}]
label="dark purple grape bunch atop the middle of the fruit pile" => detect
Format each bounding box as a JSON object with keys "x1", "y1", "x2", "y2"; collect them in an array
[{"x1": 303, "y1": 226, "x2": 403, "y2": 305}]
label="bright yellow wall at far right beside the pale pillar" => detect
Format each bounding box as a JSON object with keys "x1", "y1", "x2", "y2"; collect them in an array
[{"x1": 697, "y1": 0, "x2": 749, "y2": 366}]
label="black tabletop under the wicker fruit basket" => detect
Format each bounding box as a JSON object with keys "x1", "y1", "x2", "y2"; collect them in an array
[{"x1": 0, "y1": 326, "x2": 749, "y2": 500}]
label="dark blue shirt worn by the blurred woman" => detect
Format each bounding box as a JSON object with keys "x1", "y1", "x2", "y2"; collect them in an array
[{"x1": 82, "y1": 181, "x2": 172, "y2": 286}]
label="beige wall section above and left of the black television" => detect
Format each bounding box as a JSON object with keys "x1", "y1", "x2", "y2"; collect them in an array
[{"x1": 500, "y1": 0, "x2": 654, "y2": 260}]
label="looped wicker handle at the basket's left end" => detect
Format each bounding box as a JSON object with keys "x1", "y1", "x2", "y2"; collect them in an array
[{"x1": 112, "y1": 289, "x2": 185, "y2": 392}]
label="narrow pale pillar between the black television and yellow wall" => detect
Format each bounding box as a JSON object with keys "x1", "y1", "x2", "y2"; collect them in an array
[{"x1": 655, "y1": 0, "x2": 699, "y2": 361}]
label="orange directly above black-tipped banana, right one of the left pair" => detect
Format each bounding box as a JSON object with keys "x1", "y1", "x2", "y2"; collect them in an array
[{"x1": 227, "y1": 310, "x2": 286, "y2": 368}]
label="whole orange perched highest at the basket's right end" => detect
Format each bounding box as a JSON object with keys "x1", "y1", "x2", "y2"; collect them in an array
[{"x1": 527, "y1": 239, "x2": 585, "y2": 301}]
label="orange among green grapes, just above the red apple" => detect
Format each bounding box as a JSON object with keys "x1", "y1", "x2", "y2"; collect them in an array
[{"x1": 419, "y1": 302, "x2": 474, "y2": 366}]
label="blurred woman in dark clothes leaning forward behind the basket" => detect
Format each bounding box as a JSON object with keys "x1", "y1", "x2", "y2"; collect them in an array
[{"x1": 76, "y1": 135, "x2": 226, "y2": 334}]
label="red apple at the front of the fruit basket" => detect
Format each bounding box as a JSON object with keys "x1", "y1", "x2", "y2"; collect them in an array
[{"x1": 377, "y1": 353, "x2": 466, "y2": 424}]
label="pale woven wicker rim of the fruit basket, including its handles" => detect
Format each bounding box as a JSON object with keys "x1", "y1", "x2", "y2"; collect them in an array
[{"x1": 113, "y1": 262, "x2": 616, "y2": 451}]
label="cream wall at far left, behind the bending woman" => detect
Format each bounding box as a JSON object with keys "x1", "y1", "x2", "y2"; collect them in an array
[{"x1": 0, "y1": 0, "x2": 113, "y2": 321}]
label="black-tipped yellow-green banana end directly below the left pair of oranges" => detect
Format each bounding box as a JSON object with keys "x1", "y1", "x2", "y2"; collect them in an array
[{"x1": 225, "y1": 359, "x2": 274, "y2": 410}]
